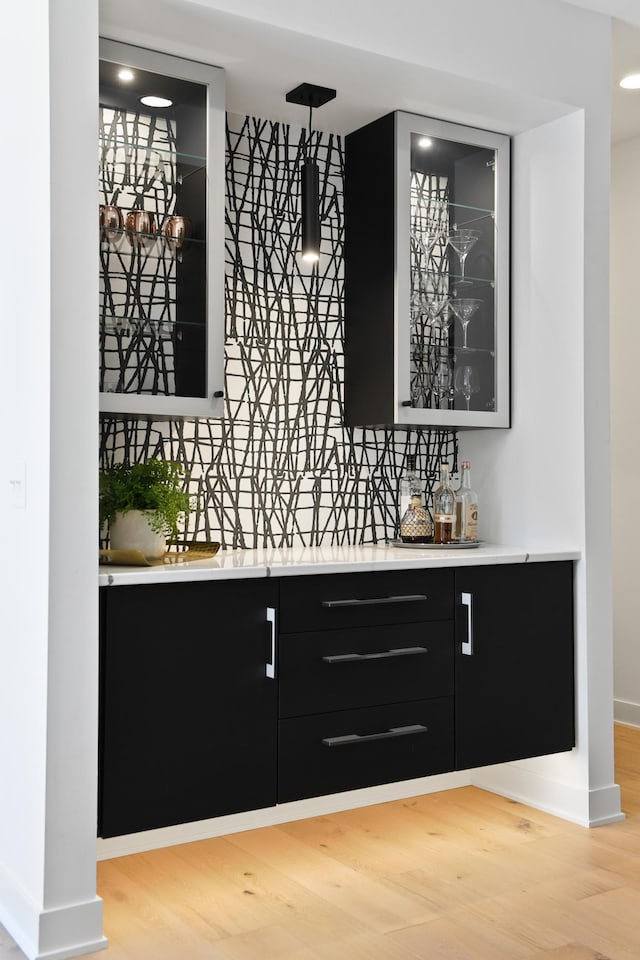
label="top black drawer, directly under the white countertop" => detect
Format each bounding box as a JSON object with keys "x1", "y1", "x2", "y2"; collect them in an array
[{"x1": 280, "y1": 569, "x2": 453, "y2": 633}]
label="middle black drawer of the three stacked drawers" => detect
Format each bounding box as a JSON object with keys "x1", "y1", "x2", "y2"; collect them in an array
[{"x1": 279, "y1": 620, "x2": 454, "y2": 717}]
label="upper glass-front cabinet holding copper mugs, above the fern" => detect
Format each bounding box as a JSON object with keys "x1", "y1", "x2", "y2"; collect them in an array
[{"x1": 97, "y1": 40, "x2": 225, "y2": 418}]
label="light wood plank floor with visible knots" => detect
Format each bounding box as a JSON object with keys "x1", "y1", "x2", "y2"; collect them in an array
[{"x1": 0, "y1": 725, "x2": 640, "y2": 960}]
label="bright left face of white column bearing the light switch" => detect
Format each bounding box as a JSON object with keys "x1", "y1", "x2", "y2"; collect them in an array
[{"x1": 0, "y1": 0, "x2": 50, "y2": 924}]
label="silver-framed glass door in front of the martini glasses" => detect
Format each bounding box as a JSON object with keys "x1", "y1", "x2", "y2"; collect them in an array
[{"x1": 396, "y1": 114, "x2": 509, "y2": 426}]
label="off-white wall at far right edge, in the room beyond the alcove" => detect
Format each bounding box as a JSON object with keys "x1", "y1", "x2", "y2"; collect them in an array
[{"x1": 611, "y1": 131, "x2": 640, "y2": 726}]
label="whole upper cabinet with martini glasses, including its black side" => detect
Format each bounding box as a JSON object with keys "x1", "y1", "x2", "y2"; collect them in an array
[{"x1": 345, "y1": 113, "x2": 510, "y2": 428}]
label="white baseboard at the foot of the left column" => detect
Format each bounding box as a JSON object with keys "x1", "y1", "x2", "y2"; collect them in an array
[{"x1": 0, "y1": 864, "x2": 108, "y2": 960}]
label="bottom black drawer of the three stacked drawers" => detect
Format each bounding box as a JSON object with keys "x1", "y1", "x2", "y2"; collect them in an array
[{"x1": 278, "y1": 697, "x2": 453, "y2": 803}]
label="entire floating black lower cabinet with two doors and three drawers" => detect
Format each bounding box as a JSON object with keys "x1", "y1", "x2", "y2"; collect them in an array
[{"x1": 99, "y1": 561, "x2": 574, "y2": 837}]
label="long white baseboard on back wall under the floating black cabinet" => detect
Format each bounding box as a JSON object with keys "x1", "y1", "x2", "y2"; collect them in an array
[{"x1": 97, "y1": 770, "x2": 471, "y2": 860}]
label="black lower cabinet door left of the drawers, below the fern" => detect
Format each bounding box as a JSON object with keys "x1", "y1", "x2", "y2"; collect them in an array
[{"x1": 99, "y1": 580, "x2": 278, "y2": 837}]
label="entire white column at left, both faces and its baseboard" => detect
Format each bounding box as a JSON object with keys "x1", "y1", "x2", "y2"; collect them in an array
[{"x1": 0, "y1": 0, "x2": 105, "y2": 958}]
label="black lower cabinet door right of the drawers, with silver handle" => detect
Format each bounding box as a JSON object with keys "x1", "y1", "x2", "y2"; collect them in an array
[{"x1": 455, "y1": 561, "x2": 575, "y2": 770}]
